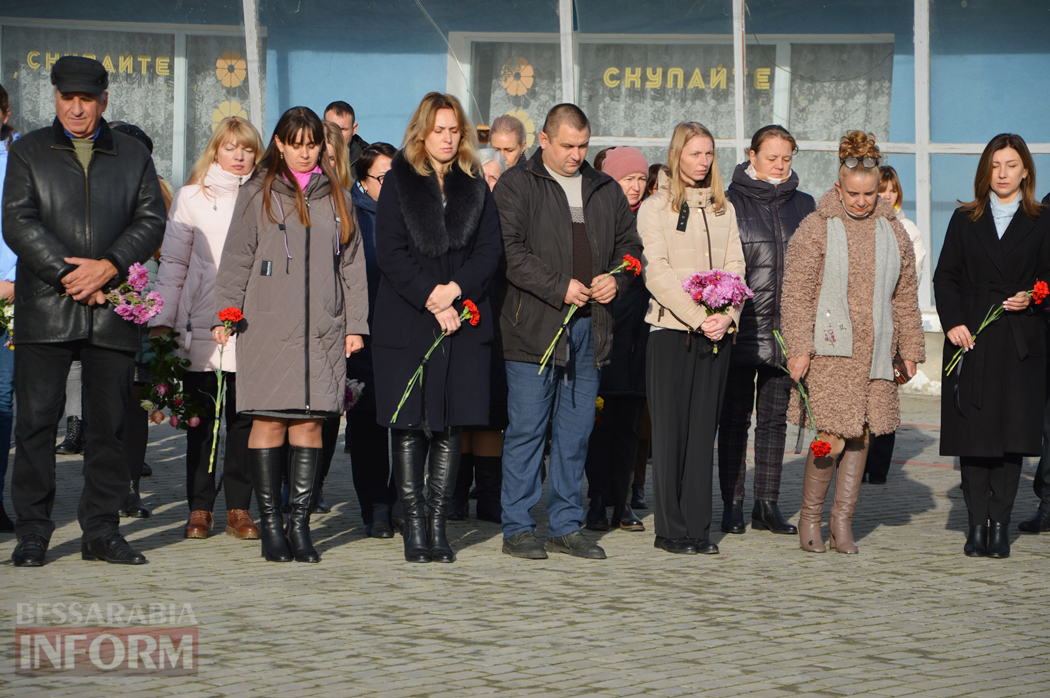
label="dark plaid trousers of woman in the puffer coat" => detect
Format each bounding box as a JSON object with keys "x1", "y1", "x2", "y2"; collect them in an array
[{"x1": 718, "y1": 366, "x2": 794, "y2": 502}]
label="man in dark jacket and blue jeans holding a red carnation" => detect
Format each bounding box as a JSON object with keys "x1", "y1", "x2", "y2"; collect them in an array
[{"x1": 494, "y1": 104, "x2": 642, "y2": 559}]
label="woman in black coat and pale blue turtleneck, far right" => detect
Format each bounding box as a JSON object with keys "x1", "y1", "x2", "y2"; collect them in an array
[{"x1": 933, "y1": 133, "x2": 1050, "y2": 558}]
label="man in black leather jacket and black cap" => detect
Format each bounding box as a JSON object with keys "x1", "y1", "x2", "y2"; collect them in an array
[{"x1": 3, "y1": 56, "x2": 165, "y2": 567}]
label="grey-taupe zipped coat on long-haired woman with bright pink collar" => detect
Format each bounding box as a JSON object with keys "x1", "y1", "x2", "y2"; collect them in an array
[{"x1": 214, "y1": 173, "x2": 369, "y2": 413}]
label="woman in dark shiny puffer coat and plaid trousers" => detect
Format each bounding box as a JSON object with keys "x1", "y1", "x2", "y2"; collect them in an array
[{"x1": 718, "y1": 126, "x2": 816, "y2": 534}]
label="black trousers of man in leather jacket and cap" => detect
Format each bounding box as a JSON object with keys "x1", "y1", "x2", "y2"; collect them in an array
[{"x1": 12, "y1": 341, "x2": 134, "y2": 541}]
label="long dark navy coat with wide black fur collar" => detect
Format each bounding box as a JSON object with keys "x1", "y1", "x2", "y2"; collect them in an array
[{"x1": 372, "y1": 153, "x2": 503, "y2": 431}]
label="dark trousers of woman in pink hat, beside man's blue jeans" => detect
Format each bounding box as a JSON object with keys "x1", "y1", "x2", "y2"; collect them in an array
[{"x1": 584, "y1": 396, "x2": 646, "y2": 506}]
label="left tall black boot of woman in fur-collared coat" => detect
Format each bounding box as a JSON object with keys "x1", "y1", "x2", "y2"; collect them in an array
[{"x1": 391, "y1": 429, "x2": 431, "y2": 563}]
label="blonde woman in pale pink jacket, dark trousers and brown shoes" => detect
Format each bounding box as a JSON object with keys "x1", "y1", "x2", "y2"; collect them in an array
[{"x1": 150, "y1": 117, "x2": 263, "y2": 538}]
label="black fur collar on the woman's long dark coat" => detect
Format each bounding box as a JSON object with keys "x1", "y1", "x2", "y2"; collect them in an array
[{"x1": 387, "y1": 152, "x2": 488, "y2": 258}]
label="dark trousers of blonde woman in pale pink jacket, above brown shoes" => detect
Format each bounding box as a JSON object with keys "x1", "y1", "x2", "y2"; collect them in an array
[{"x1": 183, "y1": 371, "x2": 252, "y2": 511}]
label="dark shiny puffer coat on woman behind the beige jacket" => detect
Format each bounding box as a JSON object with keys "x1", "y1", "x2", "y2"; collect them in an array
[{"x1": 726, "y1": 162, "x2": 817, "y2": 366}]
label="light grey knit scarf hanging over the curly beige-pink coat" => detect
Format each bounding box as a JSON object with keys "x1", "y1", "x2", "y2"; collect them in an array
[{"x1": 813, "y1": 216, "x2": 901, "y2": 380}]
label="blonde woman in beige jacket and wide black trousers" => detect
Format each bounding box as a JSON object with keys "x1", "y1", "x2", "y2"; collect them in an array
[{"x1": 638, "y1": 122, "x2": 744, "y2": 554}]
